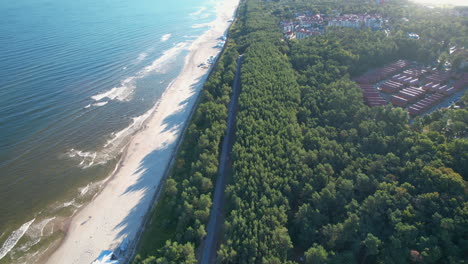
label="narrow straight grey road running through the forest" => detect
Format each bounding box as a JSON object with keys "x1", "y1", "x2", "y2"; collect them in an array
[{"x1": 201, "y1": 55, "x2": 242, "y2": 264}]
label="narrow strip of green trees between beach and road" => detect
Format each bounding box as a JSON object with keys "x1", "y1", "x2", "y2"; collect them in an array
[{"x1": 133, "y1": 26, "x2": 239, "y2": 263}]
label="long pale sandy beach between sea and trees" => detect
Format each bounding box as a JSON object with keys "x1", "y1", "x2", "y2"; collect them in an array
[{"x1": 47, "y1": 0, "x2": 238, "y2": 264}]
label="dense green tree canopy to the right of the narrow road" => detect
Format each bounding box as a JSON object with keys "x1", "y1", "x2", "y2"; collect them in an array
[{"x1": 218, "y1": 1, "x2": 468, "y2": 263}]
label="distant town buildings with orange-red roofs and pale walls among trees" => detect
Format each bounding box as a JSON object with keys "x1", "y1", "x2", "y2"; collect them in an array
[{"x1": 281, "y1": 12, "x2": 384, "y2": 39}]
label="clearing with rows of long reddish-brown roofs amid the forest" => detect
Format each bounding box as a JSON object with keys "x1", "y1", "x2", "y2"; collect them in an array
[{"x1": 355, "y1": 60, "x2": 468, "y2": 116}]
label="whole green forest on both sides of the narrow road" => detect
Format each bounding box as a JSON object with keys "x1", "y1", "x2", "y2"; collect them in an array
[{"x1": 134, "y1": 0, "x2": 468, "y2": 264}]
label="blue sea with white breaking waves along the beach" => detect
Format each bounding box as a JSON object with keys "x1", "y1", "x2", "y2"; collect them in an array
[{"x1": 0, "y1": 0, "x2": 219, "y2": 263}]
